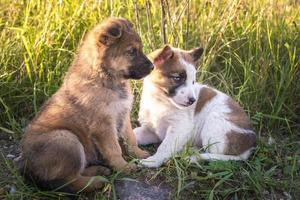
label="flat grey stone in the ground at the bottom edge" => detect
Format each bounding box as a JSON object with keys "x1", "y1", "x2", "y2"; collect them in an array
[{"x1": 116, "y1": 180, "x2": 171, "y2": 200}]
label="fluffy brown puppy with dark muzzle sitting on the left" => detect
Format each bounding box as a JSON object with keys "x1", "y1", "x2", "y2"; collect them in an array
[{"x1": 18, "y1": 18, "x2": 153, "y2": 192}]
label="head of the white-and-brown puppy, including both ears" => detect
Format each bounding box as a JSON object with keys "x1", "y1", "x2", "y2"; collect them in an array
[{"x1": 149, "y1": 45, "x2": 203, "y2": 109}]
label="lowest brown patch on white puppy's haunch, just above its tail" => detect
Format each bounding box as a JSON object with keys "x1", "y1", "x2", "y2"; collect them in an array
[{"x1": 224, "y1": 131, "x2": 256, "y2": 155}]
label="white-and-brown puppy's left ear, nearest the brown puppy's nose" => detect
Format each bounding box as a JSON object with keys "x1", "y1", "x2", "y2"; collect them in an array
[{"x1": 148, "y1": 45, "x2": 174, "y2": 67}]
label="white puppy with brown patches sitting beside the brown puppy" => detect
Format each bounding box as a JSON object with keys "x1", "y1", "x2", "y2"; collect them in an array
[{"x1": 134, "y1": 45, "x2": 256, "y2": 167}]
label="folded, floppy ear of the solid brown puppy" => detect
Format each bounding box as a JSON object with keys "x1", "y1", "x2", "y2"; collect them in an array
[{"x1": 99, "y1": 23, "x2": 122, "y2": 46}]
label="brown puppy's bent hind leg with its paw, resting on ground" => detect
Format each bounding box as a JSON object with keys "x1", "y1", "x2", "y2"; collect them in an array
[{"x1": 21, "y1": 130, "x2": 106, "y2": 192}]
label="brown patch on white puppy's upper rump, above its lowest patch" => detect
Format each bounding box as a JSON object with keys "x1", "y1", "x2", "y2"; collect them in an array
[{"x1": 227, "y1": 98, "x2": 251, "y2": 129}]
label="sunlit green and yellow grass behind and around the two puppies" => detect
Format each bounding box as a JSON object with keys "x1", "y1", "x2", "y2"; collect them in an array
[{"x1": 0, "y1": 0, "x2": 300, "y2": 199}]
